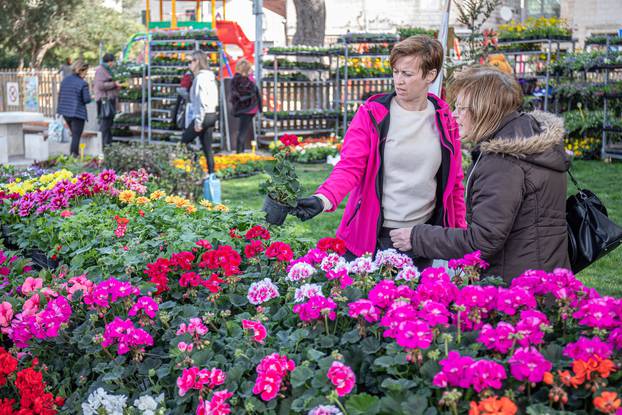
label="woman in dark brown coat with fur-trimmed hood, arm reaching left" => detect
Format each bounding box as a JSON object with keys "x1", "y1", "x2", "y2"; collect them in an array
[{"x1": 391, "y1": 67, "x2": 570, "y2": 282}]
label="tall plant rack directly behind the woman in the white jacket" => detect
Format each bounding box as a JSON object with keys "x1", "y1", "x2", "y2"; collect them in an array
[{"x1": 147, "y1": 35, "x2": 228, "y2": 147}]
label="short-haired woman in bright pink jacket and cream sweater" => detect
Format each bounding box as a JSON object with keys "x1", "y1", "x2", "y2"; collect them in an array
[{"x1": 292, "y1": 36, "x2": 466, "y2": 268}]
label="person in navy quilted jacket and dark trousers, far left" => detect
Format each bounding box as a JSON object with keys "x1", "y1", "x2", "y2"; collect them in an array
[{"x1": 57, "y1": 59, "x2": 91, "y2": 157}]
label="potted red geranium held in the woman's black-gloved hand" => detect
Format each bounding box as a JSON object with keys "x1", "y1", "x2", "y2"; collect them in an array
[{"x1": 260, "y1": 134, "x2": 301, "y2": 225}]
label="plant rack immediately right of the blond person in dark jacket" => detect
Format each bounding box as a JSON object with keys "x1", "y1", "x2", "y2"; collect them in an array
[{"x1": 257, "y1": 47, "x2": 338, "y2": 142}]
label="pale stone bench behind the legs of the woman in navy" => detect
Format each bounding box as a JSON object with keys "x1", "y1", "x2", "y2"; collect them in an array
[{"x1": 24, "y1": 122, "x2": 104, "y2": 160}]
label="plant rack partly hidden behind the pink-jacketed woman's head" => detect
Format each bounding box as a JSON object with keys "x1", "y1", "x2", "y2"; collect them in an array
[{"x1": 335, "y1": 33, "x2": 399, "y2": 136}]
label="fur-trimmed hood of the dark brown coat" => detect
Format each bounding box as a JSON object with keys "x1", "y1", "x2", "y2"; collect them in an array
[{"x1": 479, "y1": 111, "x2": 570, "y2": 171}]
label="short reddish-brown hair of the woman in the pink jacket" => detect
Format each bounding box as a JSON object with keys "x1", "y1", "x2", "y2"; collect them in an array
[{"x1": 389, "y1": 35, "x2": 443, "y2": 79}]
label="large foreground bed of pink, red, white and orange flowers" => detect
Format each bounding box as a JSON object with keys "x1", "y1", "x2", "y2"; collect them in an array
[{"x1": 0, "y1": 166, "x2": 622, "y2": 415}]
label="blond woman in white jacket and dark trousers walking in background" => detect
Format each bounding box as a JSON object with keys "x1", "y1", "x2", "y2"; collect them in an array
[{"x1": 181, "y1": 51, "x2": 218, "y2": 175}]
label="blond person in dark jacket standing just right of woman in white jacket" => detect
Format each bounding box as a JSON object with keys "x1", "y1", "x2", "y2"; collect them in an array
[{"x1": 231, "y1": 58, "x2": 261, "y2": 153}]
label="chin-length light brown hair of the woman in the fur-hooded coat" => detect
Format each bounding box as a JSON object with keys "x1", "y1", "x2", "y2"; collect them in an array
[{"x1": 448, "y1": 65, "x2": 523, "y2": 143}]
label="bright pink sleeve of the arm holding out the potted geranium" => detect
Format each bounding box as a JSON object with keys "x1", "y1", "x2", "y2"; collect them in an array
[{"x1": 316, "y1": 105, "x2": 374, "y2": 212}]
